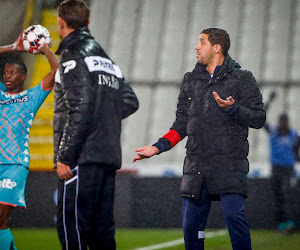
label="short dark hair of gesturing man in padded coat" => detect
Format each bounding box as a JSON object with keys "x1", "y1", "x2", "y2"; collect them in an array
[{"x1": 201, "y1": 28, "x2": 230, "y2": 55}]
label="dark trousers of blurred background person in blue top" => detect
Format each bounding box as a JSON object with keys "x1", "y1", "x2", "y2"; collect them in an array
[{"x1": 271, "y1": 165, "x2": 293, "y2": 223}]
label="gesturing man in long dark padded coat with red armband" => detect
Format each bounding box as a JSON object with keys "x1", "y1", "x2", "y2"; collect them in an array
[{"x1": 133, "y1": 28, "x2": 266, "y2": 250}]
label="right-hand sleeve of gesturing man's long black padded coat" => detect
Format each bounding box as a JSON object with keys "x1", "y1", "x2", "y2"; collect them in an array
[{"x1": 230, "y1": 71, "x2": 266, "y2": 128}]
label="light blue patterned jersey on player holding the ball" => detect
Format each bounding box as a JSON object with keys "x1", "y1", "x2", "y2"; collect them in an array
[{"x1": 0, "y1": 82, "x2": 51, "y2": 168}]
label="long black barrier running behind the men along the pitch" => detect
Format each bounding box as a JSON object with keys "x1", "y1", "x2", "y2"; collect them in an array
[{"x1": 11, "y1": 172, "x2": 300, "y2": 230}]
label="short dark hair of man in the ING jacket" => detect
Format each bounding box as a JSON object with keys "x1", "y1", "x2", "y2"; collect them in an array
[{"x1": 57, "y1": 0, "x2": 90, "y2": 30}]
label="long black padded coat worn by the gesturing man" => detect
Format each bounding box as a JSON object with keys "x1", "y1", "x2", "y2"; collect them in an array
[{"x1": 171, "y1": 55, "x2": 266, "y2": 198}]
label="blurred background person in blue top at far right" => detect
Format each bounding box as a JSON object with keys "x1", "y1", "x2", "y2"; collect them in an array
[{"x1": 265, "y1": 113, "x2": 300, "y2": 233}]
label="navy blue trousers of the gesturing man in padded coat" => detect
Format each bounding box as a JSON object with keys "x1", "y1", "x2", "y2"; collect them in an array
[{"x1": 183, "y1": 182, "x2": 251, "y2": 250}]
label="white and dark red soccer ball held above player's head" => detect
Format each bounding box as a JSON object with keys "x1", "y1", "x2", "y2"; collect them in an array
[{"x1": 23, "y1": 24, "x2": 51, "y2": 54}]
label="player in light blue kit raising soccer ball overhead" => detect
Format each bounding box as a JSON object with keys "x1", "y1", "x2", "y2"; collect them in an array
[{"x1": 0, "y1": 34, "x2": 58, "y2": 250}]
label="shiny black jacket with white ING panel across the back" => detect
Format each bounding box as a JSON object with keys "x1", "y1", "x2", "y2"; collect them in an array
[{"x1": 53, "y1": 28, "x2": 139, "y2": 169}]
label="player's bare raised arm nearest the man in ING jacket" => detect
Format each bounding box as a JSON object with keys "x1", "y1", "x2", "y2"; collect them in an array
[{"x1": 39, "y1": 43, "x2": 58, "y2": 90}]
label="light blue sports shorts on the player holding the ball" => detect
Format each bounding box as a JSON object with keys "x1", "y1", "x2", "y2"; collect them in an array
[{"x1": 0, "y1": 165, "x2": 28, "y2": 207}]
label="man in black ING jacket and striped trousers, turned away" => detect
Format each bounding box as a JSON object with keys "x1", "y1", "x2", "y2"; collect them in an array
[{"x1": 53, "y1": 0, "x2": 139, "y2": 250}]
